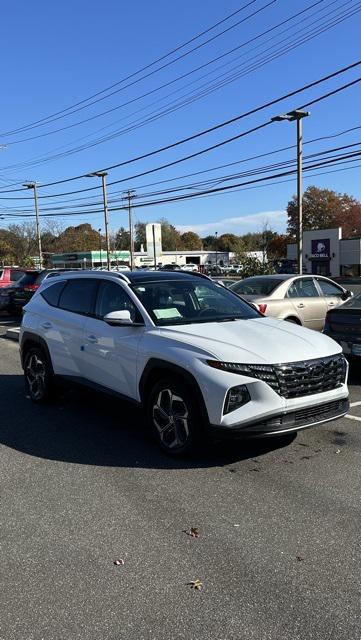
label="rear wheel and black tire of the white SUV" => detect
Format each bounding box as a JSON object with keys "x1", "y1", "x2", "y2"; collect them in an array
[{"x1": 24, "y1": 347, "x2": 54, "y2": 404}]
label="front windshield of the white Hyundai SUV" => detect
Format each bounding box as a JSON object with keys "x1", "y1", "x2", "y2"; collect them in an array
[{"x1": 132, "y1": 279, "x2": 262, "y2": 325}]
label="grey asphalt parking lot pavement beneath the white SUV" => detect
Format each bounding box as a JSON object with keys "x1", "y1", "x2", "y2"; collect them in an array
[{"x1": 0, "y1": 319, "x2": 361, "y2": 640}]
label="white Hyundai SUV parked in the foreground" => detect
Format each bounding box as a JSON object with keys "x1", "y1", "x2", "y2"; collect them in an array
[{"x1": 20, "y1": 271, "x2": 348, "y2": 454}]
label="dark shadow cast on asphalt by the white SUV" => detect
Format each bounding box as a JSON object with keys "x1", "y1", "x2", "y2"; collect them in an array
[{"x1": 0, "y1": 375, "x2": 295, "y2": 469}]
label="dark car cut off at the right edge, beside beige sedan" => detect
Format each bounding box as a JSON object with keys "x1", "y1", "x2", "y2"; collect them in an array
[{"x1": 323, "y1": 293, "x2": 361, "y2": 358}]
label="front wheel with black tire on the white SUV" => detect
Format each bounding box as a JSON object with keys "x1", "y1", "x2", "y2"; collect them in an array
[{"x1": 146, "y1": 377, "x2": 201, "y2": 456}]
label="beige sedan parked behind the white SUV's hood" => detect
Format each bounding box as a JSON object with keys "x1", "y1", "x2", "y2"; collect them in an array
[{"x1": 231, "y1": 274, "x2": 353, "y2": 331}]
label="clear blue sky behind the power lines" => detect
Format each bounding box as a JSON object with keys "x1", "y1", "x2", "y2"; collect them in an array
[{"x1": 0, "y1": 0, "x2": 361, "y2": 235}]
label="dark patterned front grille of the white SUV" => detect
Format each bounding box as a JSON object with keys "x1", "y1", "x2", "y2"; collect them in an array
[{"x1": 242, "y1": 354, "x2": 347, "y2": 398}]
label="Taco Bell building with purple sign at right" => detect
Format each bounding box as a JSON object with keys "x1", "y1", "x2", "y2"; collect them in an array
[{"x1": 287, "y1": 227, "x2": 361, "y2": 277}]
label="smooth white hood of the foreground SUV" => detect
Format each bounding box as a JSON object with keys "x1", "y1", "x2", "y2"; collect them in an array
[{"x1": 160, "y1": 317, "x2": 341, "y2": 364}]
